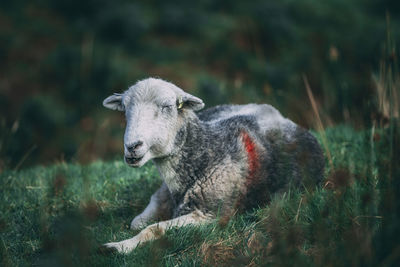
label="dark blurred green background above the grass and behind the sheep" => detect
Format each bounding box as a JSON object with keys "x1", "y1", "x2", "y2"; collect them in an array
[{"x1": 0, "y1": 0, "x2": 400, "y2": 171}]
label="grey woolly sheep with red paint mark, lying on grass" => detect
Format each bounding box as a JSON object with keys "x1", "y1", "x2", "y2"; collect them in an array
[{"x1": 103, "y1": 78, "x2": 324, "y2": 253}]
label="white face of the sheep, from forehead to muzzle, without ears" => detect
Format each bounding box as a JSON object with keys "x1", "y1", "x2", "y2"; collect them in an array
[{"x1": 123, "y1": 89, "x2": 181, "y2": 167}]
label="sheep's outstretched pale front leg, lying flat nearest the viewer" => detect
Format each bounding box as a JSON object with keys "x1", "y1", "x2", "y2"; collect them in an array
[{"x1": 104, "y1": 210, "x2": 210, "y2": 253}]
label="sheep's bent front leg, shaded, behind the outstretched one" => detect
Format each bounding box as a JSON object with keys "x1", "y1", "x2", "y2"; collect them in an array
[{"x1": 131, "y1": 183, "x2": 172, "y2": 230}]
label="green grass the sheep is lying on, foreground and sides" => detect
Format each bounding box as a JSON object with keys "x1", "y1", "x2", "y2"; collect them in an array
[{"x1": 0, "y1": 126, "x2": 400, "y2": 266}]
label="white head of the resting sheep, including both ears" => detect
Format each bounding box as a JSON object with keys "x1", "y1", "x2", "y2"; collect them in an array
[{"x1": 103, "y1": 78, "x2": 204, "y2": 167}]
